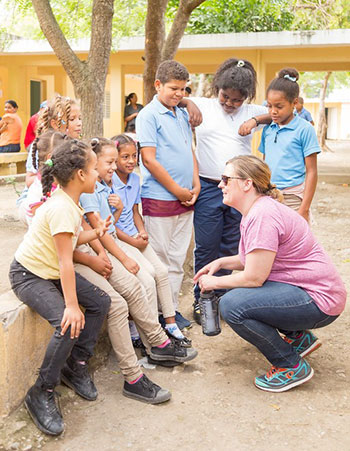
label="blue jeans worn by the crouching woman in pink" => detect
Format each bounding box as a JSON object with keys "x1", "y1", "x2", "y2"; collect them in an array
[{"x1": 219, "y1": 281, "x2": 337, "y2": 368}]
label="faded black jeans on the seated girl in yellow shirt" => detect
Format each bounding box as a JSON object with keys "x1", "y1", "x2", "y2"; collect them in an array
[{"x1": 9, "y1": 260, "x2": 111, "y2": 388}]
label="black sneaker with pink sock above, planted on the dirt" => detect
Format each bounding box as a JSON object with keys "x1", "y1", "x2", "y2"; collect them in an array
[{"x1": 123, "y1": 374, "x2": 171, "y2": 404}]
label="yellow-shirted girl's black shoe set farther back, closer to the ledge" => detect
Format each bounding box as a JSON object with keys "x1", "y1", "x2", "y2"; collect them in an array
[{"x1": 61, "y1": 357, "x2": 98, "y2": 401}]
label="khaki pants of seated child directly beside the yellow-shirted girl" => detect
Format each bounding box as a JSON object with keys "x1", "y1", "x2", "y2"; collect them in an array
[{"x1": 74, "y1": 247, "x2": 168, "y2": 382}]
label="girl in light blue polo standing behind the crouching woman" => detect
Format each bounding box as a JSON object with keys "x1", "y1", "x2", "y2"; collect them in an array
[{"x1": 259, "y1": 68, "x2": 321, "y2": 221}]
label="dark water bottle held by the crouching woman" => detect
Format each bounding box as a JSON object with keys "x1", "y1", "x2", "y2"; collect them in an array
[{"x1": 199, "y1": 291, "x2": 221, "y2": 337}]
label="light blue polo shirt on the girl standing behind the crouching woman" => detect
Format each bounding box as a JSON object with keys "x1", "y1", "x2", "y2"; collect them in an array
[{"x1": 259, "y1": 116, "x2": 321, "y2": 189}]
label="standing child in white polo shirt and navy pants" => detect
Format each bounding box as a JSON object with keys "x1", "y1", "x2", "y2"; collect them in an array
[{"x1": 181, "y1": 58, "x2": 271, "y2": 323}]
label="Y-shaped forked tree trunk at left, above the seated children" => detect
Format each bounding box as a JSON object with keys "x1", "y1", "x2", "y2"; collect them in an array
[{"x1": 32, "y1": 0, "x2": 114, "y2": 137}]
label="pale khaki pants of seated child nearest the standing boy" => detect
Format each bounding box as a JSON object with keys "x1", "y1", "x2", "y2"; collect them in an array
[{"x1": 118, "y1": 240, "x2": 175, "y2": 318}]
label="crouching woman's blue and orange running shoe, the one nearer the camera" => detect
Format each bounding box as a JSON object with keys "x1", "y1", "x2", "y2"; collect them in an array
[{"x1": 255, "y1": 359, "x2": 314, "y2": 392}]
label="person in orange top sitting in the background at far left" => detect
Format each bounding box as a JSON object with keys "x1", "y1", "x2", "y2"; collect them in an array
[{"x1": 0, "y1": 100, "x2": 23, "y2": 153}]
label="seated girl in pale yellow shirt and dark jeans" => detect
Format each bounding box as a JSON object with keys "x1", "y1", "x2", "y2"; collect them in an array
[{"x1": 9, "y1": 140, "x2": 110, "y2": 435}]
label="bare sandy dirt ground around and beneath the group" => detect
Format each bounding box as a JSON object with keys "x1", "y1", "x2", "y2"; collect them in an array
[{"x1": 0, "y1": 147, "x2": 350, "y2": 451}]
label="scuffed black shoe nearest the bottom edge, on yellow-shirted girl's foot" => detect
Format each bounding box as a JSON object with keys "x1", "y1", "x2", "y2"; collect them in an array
[{"x1": 24, "y1": 384, "x2": 64, "y2": 435}]
